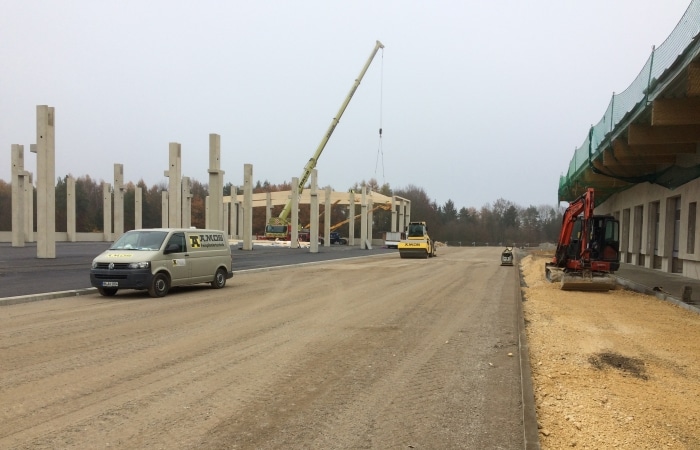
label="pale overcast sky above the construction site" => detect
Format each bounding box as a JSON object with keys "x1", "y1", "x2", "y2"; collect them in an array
[{"x1": 0, "y1": 0, "x2": 690, "y2": 209}]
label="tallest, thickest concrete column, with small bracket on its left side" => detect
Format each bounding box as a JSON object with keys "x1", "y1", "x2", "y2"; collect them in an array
[{"x1": 30, "y1": 105, "x2": 56, "y2": 258}]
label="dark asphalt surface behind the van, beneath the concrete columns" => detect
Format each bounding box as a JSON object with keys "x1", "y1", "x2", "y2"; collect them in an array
[{"x1": 0, "y1": 242, "x2": 398, "y2": 299}]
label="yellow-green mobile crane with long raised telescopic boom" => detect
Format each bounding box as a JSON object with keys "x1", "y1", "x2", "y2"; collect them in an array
[{"x1": 265, "y1": 41, "x2": 384, "y2": 240}]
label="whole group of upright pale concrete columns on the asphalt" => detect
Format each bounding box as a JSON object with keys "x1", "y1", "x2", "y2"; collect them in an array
[{"x1": 12, "y1": 105, "x2": 410, "y2": 258}]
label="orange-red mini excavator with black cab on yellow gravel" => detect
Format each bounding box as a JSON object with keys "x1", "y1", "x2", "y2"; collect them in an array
[{"x1": 545, "y1": 188, "x2": 620, "y2": 291}]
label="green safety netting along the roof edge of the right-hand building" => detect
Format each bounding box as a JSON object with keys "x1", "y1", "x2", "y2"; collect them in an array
[{"x1": 559, "y1": 0, "x2": 700, "y2": 204}]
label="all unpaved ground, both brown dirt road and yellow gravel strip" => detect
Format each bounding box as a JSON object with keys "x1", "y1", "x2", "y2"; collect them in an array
[{"x1": 0, "y1": 247, "x2": 700, "y2": 449}]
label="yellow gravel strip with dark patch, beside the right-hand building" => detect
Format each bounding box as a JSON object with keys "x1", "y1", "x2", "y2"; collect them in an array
[{"x1": 521, "y1": 254, "x2": 700, "y2": 449}]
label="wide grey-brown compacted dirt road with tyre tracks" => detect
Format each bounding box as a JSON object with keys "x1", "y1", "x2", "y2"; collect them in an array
[{"x1": 0, "y1": 248, "x2": 523, "y2": 449}]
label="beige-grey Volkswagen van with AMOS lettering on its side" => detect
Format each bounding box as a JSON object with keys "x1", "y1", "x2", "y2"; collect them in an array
[{"x1": 90, "y1": 228, "x2": 233, "y2": 297}]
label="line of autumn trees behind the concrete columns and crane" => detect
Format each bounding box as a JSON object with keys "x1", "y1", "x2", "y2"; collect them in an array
[{"x1": 0, "y1": 175, "x2": 563, "y2": 246}]
